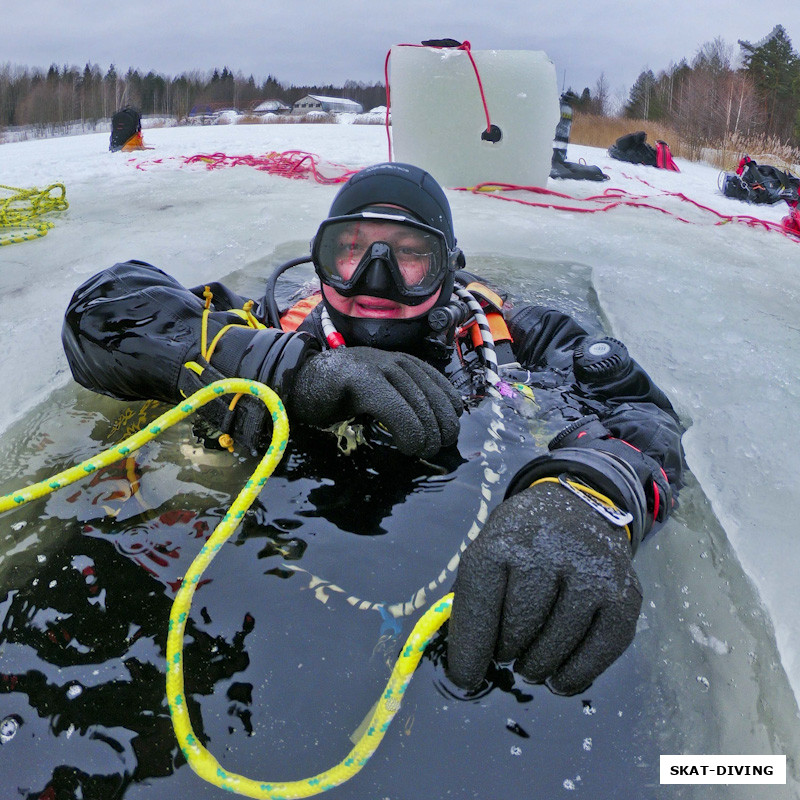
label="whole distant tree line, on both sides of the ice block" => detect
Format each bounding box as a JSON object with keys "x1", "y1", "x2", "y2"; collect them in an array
[{"x1": 0, "y1": 25, "x2": 800, "y2": 148}]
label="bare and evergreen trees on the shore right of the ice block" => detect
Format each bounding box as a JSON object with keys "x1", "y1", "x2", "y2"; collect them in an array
[{"x1": 575, "y1": 25, "x2": 800, "y2": 149}]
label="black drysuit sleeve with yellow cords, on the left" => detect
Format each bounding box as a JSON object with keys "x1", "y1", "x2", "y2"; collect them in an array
[{"x1": 61, "y1": 261, "x2": 319, "y2": 447}]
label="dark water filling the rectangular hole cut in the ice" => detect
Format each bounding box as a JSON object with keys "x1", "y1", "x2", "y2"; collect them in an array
[{"x1": 0, "y1": 265, "x2": 794, "y2": 800}]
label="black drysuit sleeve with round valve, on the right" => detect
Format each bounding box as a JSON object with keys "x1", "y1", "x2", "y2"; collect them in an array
[{"x1": 507, "y1": 306, "x2": 683, "y2": 547}]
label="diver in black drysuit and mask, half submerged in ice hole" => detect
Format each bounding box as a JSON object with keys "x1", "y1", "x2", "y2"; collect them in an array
[{"x1": 62, "y1": 163, "x2": 682, "y2": 694}]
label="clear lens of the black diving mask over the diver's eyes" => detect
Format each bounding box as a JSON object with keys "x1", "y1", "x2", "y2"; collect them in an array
[{"x1": 312, "y1": 216, "x2": 448, "y2": 297}]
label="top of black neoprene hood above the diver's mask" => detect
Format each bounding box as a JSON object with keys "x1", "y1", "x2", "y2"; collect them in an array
[{"x1": 329, "y1": 162, "x2": 456, "y2": 250}]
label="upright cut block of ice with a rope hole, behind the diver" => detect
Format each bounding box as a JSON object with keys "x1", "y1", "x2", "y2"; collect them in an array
[{"x1": 389, "y1": 45, "x2": 559, "y2": 187}]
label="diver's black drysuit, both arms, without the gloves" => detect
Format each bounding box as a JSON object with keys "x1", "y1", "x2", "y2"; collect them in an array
[{"x1": 62, "y1": 261, "x2": 682, "y2": 547}]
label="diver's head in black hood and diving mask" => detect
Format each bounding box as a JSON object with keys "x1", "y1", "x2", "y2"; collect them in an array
[{"x1": 311, "y1": 163, "x2": 461, "y2": 350}]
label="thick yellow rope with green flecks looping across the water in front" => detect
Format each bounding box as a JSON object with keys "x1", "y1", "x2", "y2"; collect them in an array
[{"x1": 0, "y1": 378, "x2": 453, "y2": 800}]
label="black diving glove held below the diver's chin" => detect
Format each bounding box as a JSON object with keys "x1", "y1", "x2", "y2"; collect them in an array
[{"x1": 287, "y1": 347, "x2": 463, "y2": 458}]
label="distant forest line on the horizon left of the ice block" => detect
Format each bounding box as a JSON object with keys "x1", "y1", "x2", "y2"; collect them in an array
[{"x1": 0, "y1": 63, "x2": 386, "y2": 130}]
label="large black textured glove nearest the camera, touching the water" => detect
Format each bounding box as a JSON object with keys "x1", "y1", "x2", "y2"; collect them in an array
[{"x1": 447, "y1": 481, "x2": 642, "y2": 695}]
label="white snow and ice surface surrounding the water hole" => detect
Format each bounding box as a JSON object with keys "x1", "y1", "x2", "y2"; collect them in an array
[{"x1": 0, "y1": 124, "x2": 800, "y2": 712}]
